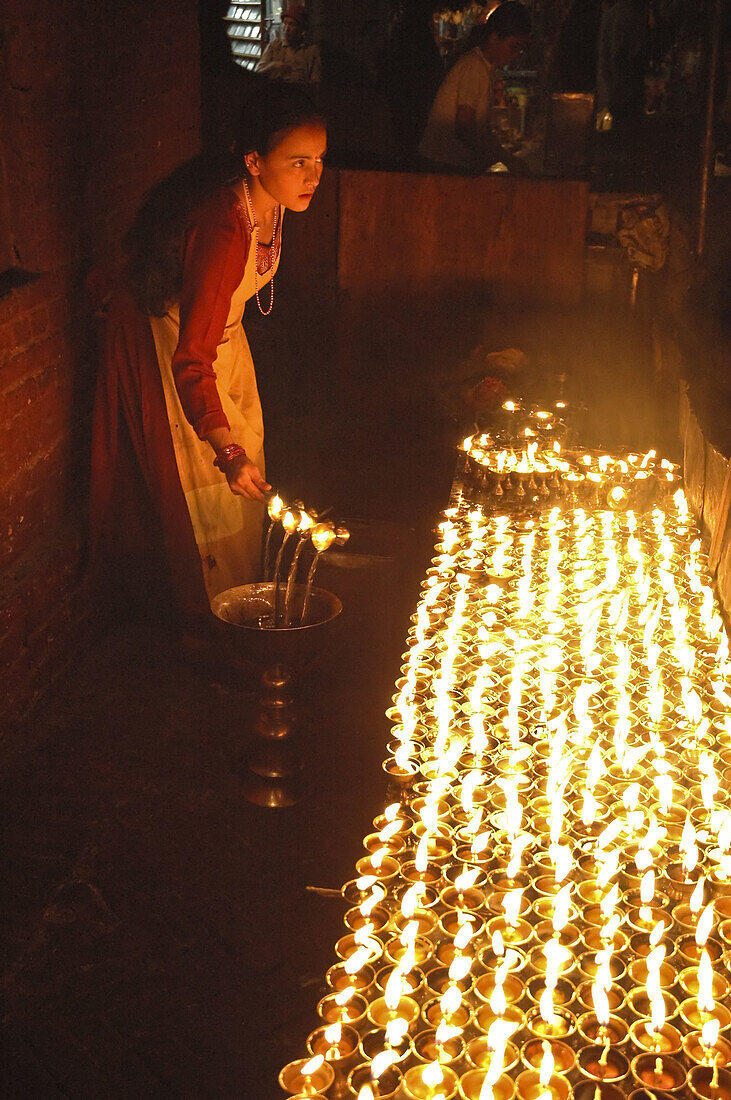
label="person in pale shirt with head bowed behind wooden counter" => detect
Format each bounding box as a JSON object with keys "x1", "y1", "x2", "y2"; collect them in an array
[{"x1": 419, "y1": 0, "x2": 531, "y2": 173}]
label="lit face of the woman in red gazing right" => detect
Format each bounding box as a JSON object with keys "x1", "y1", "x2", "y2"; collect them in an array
[{"x1": 246, "y1": 122, "x2": 328, "y2": 211}]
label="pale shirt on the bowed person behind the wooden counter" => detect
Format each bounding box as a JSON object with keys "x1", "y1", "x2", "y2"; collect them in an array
[{"x1": 419, "y1": 47, "x2": 495, "y2": 168}]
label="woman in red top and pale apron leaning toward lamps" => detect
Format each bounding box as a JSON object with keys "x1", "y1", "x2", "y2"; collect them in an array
[{"x1": 91, "y1": 89, "x2": 325, "y2": 626}]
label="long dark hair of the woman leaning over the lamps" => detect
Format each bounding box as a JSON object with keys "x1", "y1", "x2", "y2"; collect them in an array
[{"x1": 123, "y1": 81, "x2": 325, "y2": 317}]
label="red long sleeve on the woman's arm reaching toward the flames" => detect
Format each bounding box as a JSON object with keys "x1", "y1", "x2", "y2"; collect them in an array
[{"x1": 173, "y1": 187, "x2": 251, "y2": 439}]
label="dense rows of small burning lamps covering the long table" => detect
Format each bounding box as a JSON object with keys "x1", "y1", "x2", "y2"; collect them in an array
[{"x1": 281, "y1": 439, "x2": 731, "y2": 1100}]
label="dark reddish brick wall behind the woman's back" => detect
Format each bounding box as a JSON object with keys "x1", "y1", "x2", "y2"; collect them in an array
[{"x1": 0, "y1": 0, "x2": 200, "y2": 728}]
